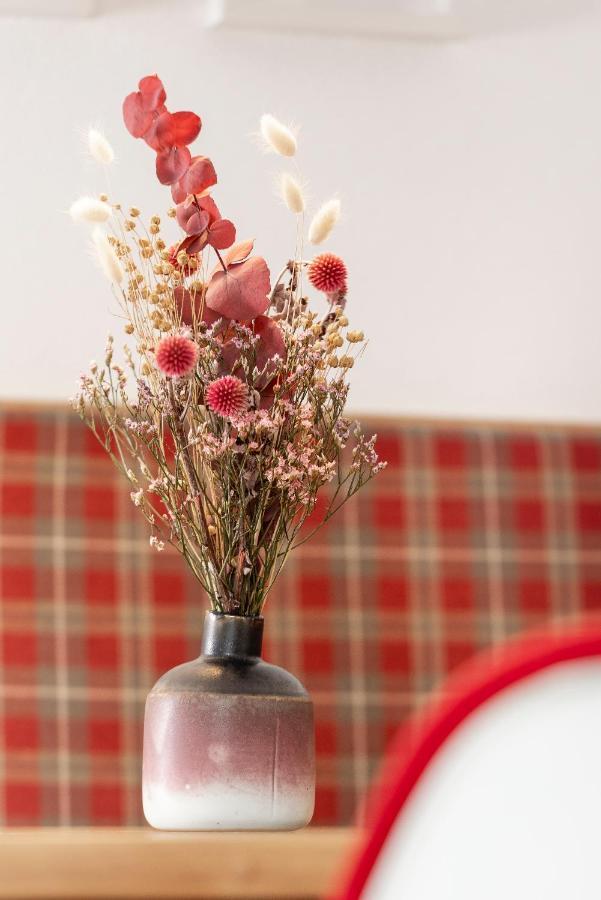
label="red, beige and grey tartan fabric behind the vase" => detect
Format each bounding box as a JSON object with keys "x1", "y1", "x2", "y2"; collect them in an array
[{"x1": 0, "y1": 407, "x2": 601, "y2": 825}]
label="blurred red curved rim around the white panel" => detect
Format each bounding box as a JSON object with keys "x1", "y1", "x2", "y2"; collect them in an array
[{"x1": 331, "y1": 618, "x2": 601, "y2": 900}]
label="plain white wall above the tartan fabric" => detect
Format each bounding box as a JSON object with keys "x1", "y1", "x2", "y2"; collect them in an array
[{"x1": 0, "y1": 8, "x2": 601, "y2": 422}]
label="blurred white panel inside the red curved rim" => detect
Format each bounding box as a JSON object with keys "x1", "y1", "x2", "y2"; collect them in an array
[{"x1": 365, "y1": 660, "x2": 601, "y2": 900}]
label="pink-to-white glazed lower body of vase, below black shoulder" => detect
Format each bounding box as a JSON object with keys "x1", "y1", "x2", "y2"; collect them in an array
[{"x1": 143, "y1": 688, "x2": 315, "y2": 830}]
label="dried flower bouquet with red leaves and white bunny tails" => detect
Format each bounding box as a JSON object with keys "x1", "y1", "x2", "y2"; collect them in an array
[{"x1": 71, "y1": 75, "x2": 383, "y2": 616}]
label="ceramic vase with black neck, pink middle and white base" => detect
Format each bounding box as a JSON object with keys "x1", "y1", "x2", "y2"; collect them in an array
[{"x1": 142, "y1": 612, "x2": 315, "y2": 831}]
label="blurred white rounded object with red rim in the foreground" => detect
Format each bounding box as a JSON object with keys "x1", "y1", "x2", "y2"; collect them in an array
[{"x1": 331, "y1": 618, "x2": 601, "y2": 900}]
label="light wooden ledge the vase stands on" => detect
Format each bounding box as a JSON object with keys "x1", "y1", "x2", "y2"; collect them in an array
[{"x1": 0, "y1": 828, "x2": 358, "y2": 900}]
